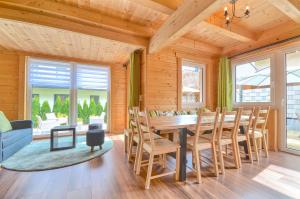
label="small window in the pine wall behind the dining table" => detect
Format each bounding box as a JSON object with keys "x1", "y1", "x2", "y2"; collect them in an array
[{"x1": 181, "y1": 60, "x2": 205, "y2": 109}]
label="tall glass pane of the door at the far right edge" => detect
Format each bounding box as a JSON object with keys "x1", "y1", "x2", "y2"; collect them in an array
[{"x1": 286, "y1": 51, "x2": 300, "y2": 150}]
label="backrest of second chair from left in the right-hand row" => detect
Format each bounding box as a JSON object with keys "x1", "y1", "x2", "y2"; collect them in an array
[{"x1": 217, "y1": 107, "x2": 242, "y2": 139}]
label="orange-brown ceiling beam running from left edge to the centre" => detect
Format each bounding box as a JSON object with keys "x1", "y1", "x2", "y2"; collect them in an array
[{"x1": 0, "y1": 2, "x2": 149, "y2": 47}]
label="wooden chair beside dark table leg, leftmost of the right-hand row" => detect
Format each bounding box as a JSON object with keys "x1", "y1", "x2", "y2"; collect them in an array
[{"x1": 187, "y1": 108, "x2": 220, "y2": 183}]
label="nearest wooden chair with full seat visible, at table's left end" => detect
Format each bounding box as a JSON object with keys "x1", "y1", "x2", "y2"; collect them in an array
[{"x1": 138, "y1": 111, "x2": 180, "y2": 189}]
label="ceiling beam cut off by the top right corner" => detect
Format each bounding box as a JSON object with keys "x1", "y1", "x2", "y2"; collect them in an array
[{"x1": 269, "y1": 0, "x2": 300, "y2": 23}]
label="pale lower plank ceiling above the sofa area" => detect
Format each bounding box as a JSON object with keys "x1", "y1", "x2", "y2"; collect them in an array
[{"x1": 0, "y1": 20, "x2": 137, "y2": 63}]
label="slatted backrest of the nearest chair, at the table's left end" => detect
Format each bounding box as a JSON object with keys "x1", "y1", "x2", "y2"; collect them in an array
[{"x1": 137, "y1": 109, "x2": 154, "y2": 146}]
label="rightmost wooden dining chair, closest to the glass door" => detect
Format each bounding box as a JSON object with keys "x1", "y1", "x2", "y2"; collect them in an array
[{"x1": 250, "y1": 106, "x2": 271, "y2": 161}]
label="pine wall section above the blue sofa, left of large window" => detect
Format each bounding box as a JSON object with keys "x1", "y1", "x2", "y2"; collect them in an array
[{"x1": 0, "y1": 52, "x2": 19, "y2": 120}]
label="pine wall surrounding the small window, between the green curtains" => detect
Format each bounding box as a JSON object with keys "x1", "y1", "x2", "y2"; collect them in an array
[{"x1": 142, "y1": 48, "x2": 218, "y2": 110}]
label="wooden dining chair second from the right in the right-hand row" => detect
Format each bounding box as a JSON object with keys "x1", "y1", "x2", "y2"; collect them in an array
[{"x1": 236, "y1": 108, "x2": 255, "y2": 167}]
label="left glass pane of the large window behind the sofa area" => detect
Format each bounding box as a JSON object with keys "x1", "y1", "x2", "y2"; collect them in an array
[{"x1": 29, "y1": 59, "x2": 71, "y2": 135}]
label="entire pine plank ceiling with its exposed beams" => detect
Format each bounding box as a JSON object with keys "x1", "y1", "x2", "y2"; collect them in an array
[{"x1": 0, "y1": 0, "x2": 300, "y2": 63}]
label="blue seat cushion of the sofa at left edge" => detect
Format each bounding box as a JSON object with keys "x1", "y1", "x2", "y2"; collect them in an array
[{"x1": 2, "y1": 128, "x2": 32, "y2": 149}]
